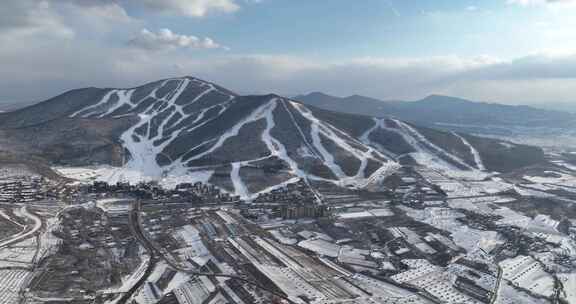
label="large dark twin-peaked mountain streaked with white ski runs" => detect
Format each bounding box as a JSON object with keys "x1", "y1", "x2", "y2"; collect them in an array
[{"x1": 0, "y1": 77, "x2": 542, "y2": 197}]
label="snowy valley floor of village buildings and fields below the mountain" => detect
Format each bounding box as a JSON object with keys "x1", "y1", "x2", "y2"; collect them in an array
[{"x1": 0, "y1": 167, "x2": 576, "y2": 304}]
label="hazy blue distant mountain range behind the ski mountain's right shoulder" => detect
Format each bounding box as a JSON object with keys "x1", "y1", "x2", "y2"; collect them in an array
[{"x1": 294, "y1": 92, "x2": 576, "y2": 135}]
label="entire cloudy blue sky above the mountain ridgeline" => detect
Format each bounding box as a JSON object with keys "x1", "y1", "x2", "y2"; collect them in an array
[{"x1": 0, "y1": 0, "x2": 576, "y2": 104}]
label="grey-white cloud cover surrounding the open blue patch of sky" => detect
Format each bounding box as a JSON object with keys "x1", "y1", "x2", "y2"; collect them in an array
[{"x1": 0, "y1": 0, "x2": 576, "y2": 103}]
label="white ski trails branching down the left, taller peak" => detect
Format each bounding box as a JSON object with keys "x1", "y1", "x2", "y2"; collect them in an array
[{"x1": 69, "y1": 78, "x2": 235, "y2": 182}]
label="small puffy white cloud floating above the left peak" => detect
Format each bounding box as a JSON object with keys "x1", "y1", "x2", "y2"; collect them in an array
[{"x1": 129, "y1": 29, "x2": 224, "y2": 50}]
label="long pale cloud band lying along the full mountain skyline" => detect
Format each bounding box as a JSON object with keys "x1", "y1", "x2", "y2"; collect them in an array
[{"x1": 5, "y1": 41, "x2": 576, "y2": 103}]
